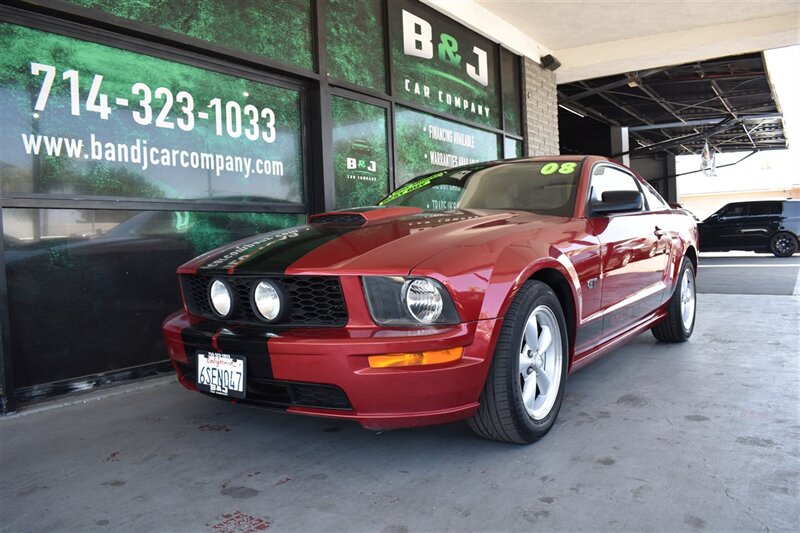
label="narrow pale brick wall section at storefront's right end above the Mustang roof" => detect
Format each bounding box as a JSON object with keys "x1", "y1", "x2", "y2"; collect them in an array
[{"x1": 523, "y1": 57, "x2": 559, "y2": 156}]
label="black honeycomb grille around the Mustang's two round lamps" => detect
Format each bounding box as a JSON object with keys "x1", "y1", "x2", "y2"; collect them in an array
[{"x1": 181, "y1": 275, "x2": 347, "y2": 327}]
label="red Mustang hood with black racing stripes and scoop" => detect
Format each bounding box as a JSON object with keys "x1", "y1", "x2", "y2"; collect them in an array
[{"x1": 179, "y1": 208, "x2": 569, "y2": 275}]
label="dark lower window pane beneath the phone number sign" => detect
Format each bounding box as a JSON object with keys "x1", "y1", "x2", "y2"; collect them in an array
[{"x1": 2, "y1": 208, "x2": 305, "y2": 394}]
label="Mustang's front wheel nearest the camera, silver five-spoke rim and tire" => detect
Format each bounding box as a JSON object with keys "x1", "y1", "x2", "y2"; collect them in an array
[{"x1": 468, "y1": 280, "x2": 569, "y2": 444}]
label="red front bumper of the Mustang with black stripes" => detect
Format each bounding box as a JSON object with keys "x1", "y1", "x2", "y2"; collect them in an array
[{"x1": 164, "y1": 312, "x2": 501, "y2": 429}]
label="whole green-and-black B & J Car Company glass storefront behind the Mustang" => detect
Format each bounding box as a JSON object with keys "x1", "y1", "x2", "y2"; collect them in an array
[{"x1": 0, "y1": 0, "x2": 523, "y2": 406}]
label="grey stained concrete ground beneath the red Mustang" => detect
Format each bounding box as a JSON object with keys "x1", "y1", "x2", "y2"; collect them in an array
[{"x1": 0, "y1": 294, "x2": 800, "y2": 532}]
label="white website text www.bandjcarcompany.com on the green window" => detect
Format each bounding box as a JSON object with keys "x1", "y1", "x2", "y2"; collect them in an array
[{"x1": 22, "y1": 133, "x2": 284, "y2": 178}]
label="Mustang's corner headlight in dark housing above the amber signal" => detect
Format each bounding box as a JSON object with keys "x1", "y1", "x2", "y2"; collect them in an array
[{"x1": 362, "y1": 276, "x2": 459, "y2": 326}]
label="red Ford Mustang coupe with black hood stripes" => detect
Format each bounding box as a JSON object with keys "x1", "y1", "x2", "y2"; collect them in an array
[{"x1": 164, "y1": 156, "x2": 697, "y2": 443}]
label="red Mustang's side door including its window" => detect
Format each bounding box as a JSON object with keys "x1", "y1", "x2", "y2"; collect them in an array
[{"x1": 589, "y1": 163, "x2": 670, "y2": 339}]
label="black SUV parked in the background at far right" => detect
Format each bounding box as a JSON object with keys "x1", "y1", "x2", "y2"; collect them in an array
[{"x1": 697, "y1": 200, "x2": 800, "y2": 257}]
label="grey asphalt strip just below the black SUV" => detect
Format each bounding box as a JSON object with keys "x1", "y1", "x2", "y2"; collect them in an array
[{"x1": 697, "y1": 252, "x2": 800, "y2": 295}]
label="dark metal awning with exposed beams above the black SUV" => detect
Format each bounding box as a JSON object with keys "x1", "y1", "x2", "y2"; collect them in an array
[{"x1": 558, "y1": 53, "x2": 786, "y2": 155}]
